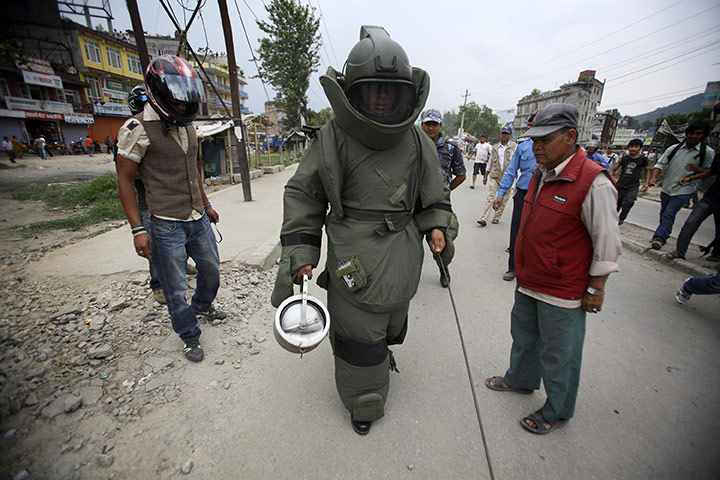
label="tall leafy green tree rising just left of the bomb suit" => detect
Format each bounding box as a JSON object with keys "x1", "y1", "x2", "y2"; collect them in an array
[{"x1": 256, "y1": 0, "x2": 321, "y2": 130}]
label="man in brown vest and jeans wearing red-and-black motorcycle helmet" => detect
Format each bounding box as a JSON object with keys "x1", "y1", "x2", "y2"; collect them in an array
[{"x1": 117, "y1": 55, "x2": 227, "y2": 362}]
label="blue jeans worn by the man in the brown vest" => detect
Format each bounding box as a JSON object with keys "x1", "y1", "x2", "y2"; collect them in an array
[{"x1": 150, "y1": 215, "x2": 220, "y2": 341}]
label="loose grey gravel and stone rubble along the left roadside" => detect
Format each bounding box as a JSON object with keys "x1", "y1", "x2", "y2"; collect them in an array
[{"x1": 0, "y1": 260, "x2": 275, "y2": 478}]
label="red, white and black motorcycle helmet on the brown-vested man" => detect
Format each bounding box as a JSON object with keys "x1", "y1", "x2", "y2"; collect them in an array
[{"x1": 145, "y1": 55, "x2": 205, "y2": 126}]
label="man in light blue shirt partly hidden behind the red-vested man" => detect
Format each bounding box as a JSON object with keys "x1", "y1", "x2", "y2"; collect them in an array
[{"x1": 493, "y1": 114, "x2": 537, "y2": 282}]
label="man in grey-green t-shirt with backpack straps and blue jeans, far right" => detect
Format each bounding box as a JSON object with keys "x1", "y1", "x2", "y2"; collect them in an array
[{"x1": 650, "y1": 122, "x2": 715, "y2": 250}]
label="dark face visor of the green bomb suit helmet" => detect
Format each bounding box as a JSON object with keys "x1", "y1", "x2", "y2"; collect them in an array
[{"x1": 348, "y1": 78, "x2": 415, "y2": 125}]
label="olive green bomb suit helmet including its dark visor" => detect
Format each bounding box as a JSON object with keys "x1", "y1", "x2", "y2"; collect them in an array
[{"x1": 344, "y1": 26, "x2": 416, "y2": 125}]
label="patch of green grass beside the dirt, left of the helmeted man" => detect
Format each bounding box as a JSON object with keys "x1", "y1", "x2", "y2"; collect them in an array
[{"x1": 12, "y1": 173, "x2": 125, "y2": 235}]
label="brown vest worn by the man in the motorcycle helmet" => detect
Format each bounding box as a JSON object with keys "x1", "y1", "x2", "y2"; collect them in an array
[{"x1": 135, "y1": 116, "x2": 203, "y2": 220}]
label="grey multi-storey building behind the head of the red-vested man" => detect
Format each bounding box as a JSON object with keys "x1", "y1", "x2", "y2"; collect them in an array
[{"x1": 514, "y1": 70, "x2": 605, "y2": 143}]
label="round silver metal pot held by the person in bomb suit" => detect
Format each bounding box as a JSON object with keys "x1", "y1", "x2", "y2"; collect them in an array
[{"x1": 273, "y1": 275, "x2": 330, "y2": 356}]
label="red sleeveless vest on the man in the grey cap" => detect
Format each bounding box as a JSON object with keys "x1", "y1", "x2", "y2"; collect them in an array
[{"x1": 515, "y1": 148, "x2": 607, "y2": 300}]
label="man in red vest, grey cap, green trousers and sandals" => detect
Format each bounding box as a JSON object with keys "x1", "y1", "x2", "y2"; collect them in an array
[{"x1": 485, "y1": 103, "x2": 622, "y2": 434}]
